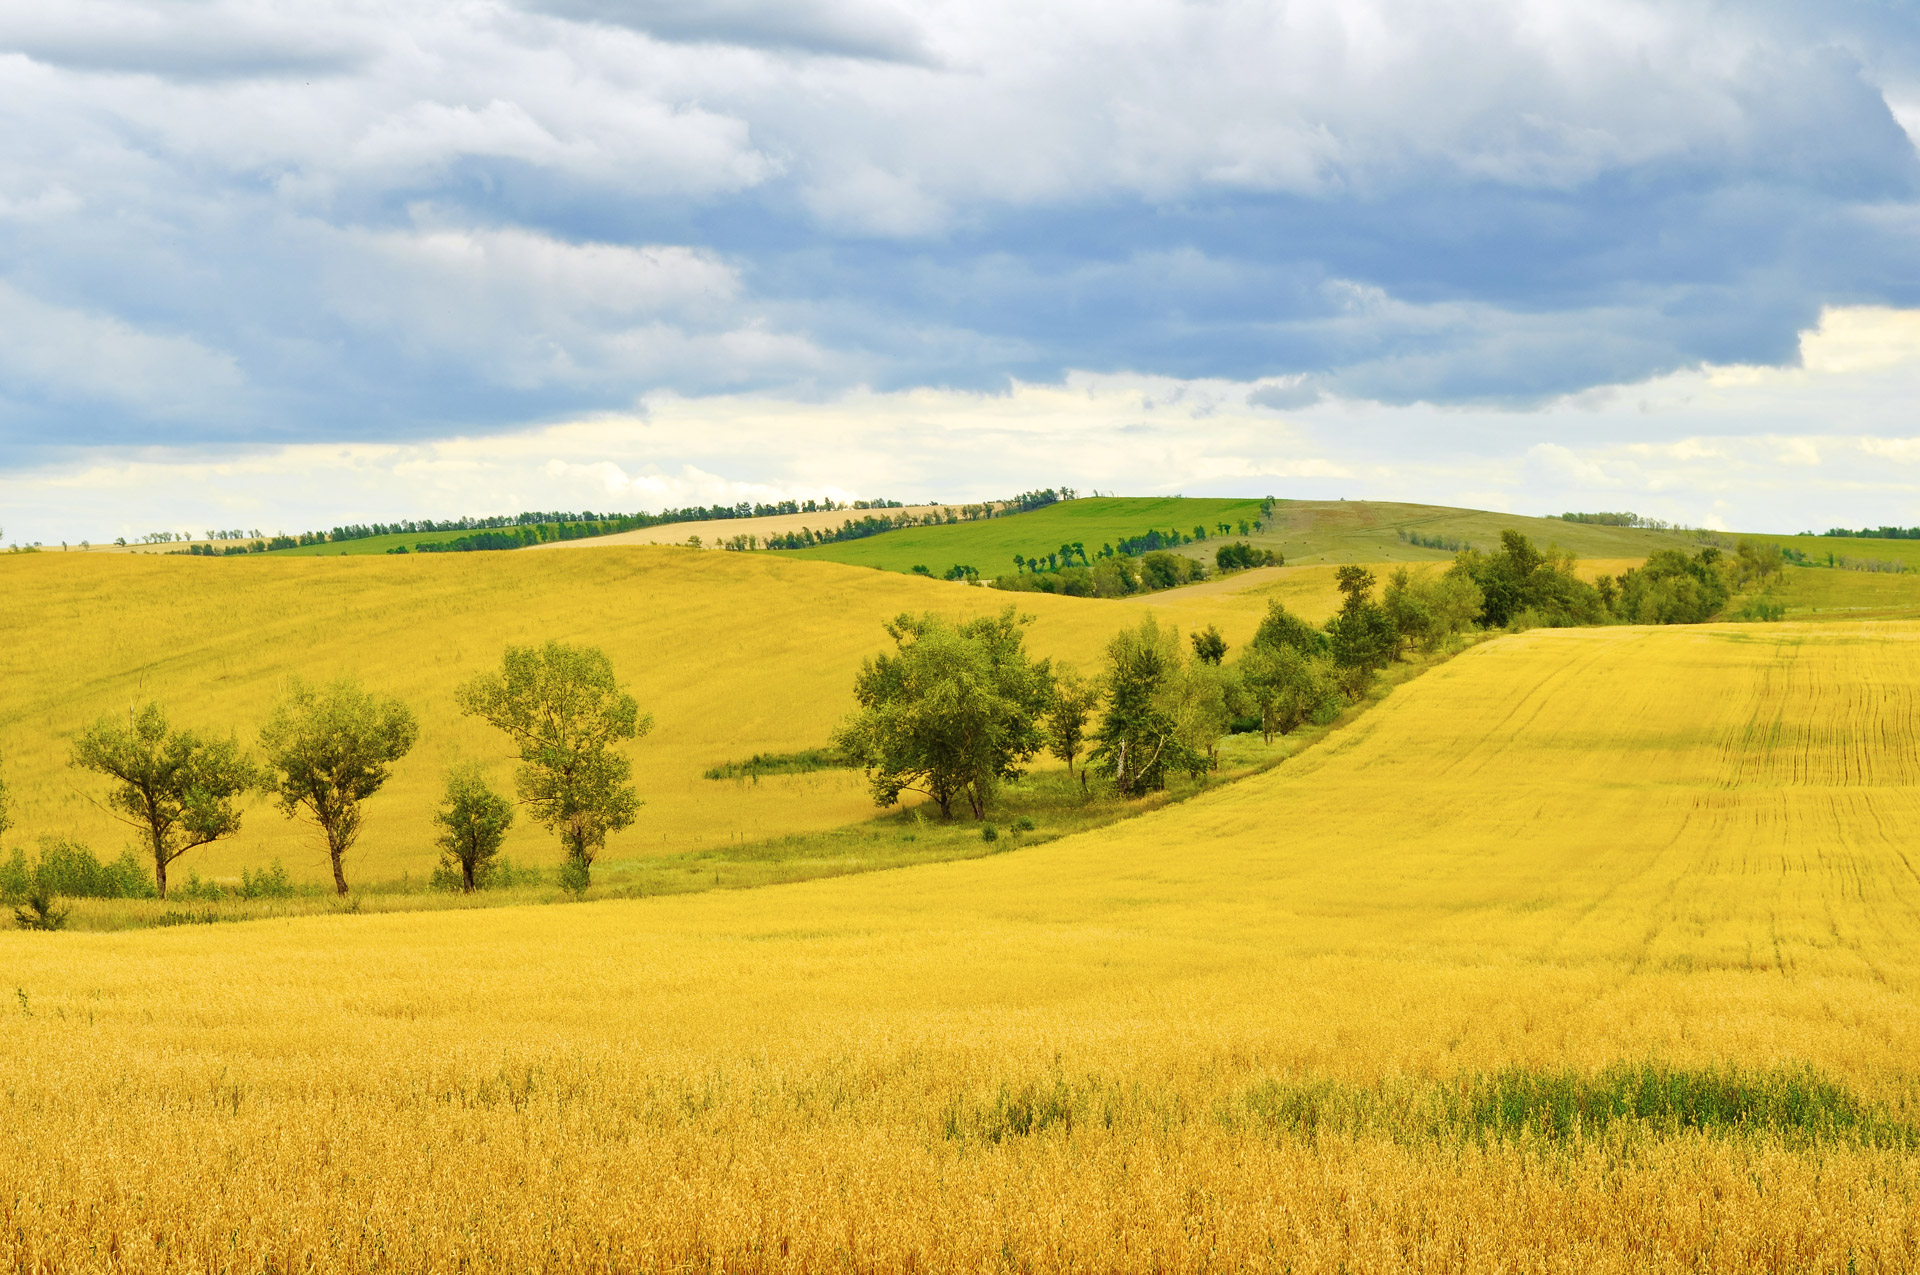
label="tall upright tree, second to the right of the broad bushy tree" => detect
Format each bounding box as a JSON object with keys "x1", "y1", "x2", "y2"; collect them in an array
[{"x1": 1089, "y1": 616, "x2": 1208, "y2": 797}]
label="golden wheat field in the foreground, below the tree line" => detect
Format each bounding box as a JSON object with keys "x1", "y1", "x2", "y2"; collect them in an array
[{"x1": 0, "y1": 618, "x2": 1920, "y2": 1271}]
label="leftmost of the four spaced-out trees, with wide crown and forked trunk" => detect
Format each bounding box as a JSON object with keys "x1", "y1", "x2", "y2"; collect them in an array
[{"x1": 69, "y1": 703, "x2": 261, "y2": 899}]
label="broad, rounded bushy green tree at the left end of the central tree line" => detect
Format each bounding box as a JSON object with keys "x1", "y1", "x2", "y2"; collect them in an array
[{"x1": 833, "y1": 607, "x2": 1054, "y2": 820}]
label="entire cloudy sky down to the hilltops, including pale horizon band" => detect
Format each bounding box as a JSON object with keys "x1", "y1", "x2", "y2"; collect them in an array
[{"x1": 0, "y1": 0, "x2": 1920, "y2": 543}]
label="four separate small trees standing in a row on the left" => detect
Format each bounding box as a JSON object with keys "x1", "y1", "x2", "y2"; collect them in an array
[{"x1": 0, "y1": 641, "x2": 653, "y2": 899}]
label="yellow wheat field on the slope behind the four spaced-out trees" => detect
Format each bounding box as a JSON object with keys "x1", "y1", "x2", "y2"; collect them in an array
[{"x1": 0, "y1": 541, "x2": 1332, "y2": 881}]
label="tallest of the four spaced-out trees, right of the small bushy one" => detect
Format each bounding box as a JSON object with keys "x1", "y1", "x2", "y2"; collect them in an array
[{"x1": 457, "y1": 641, "x2": 653, "y2": 889}]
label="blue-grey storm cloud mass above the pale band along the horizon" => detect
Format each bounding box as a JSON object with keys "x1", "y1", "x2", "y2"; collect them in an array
[{"x1": 0, "y1": 0, "x2": 1920, "y2": 465}]
